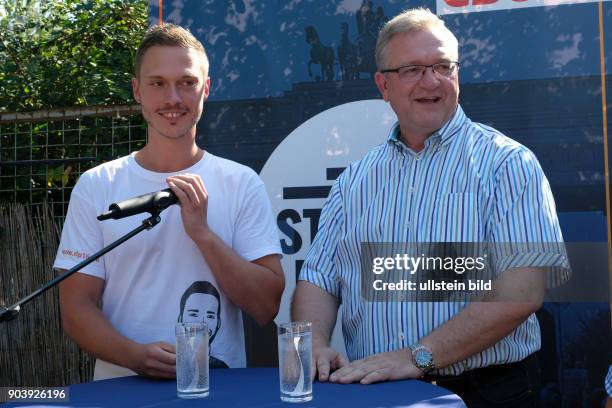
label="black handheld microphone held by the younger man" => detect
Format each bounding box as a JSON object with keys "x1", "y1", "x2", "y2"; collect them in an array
[{"x1": 98, "y1": 188, "x2": 178, "y2": 221}]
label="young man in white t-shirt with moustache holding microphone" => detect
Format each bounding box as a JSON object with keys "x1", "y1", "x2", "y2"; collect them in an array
[{"x1": 54, "y1": 24, "x2": 284, "y2": 379}]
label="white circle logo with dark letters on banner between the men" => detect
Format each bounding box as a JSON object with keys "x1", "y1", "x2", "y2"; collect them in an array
[{"x1": 260, "y1": 99, "x2": 397, "y2": 352}]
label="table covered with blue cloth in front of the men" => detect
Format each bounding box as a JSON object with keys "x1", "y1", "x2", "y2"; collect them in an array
[{"x1": 3, "y1": 368, "x2": 465, "y2": 408}]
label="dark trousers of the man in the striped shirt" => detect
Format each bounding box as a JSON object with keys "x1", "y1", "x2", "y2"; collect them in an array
[{"x1": 423, "y1": 354, "x2": 540, "y2": 408}]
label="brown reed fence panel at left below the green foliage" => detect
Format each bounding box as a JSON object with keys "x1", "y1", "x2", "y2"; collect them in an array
[{"x1": 0, "y1": 203, "x2": 93, "y2": 387}]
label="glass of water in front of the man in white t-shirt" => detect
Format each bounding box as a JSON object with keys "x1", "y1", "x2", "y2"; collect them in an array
[{"x1": 175, "y1": 323, "x2": 208, "y2": 398}]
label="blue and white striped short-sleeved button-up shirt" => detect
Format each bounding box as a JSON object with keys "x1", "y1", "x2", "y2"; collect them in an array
[{"x1": 300, "y1": 107, "x2": 569, "y2": 375}]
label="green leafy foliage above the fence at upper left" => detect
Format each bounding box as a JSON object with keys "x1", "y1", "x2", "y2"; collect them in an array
[{"x1": 0, "y1": 0, "x2": 148, "y2": 111}]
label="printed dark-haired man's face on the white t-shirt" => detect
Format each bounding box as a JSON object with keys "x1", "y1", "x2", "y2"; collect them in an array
[{"x1": 178, "y1": 281, "x2": 229, "y2": 368}]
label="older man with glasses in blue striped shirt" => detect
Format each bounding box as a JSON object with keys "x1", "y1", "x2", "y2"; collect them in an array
[{"x1": 292, "y1": 9, "x2": 569, "y2": 407}]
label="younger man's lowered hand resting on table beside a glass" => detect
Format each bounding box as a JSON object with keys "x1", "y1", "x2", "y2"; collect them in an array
[{"x1": 128, "y1": 341, "x2": 176, "y2": 378}]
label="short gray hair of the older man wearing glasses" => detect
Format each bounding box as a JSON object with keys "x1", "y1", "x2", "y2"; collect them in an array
[{"x1": 376, "y1": 7, "x2": 459, "y2": 71}]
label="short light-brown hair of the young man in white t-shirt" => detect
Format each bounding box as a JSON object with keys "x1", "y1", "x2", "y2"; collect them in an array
[{"x1": 134, "y1": 23, "x2": 209, "y2": 78}]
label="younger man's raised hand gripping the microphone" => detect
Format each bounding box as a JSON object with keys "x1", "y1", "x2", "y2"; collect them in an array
[{"x1": 166, "y1": 174, "x2": 209, "y2": 240}]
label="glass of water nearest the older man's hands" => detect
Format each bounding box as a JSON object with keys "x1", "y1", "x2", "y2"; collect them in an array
[{"x1": 278, "y1": 322, "x2": 312, "y2": 402}]
